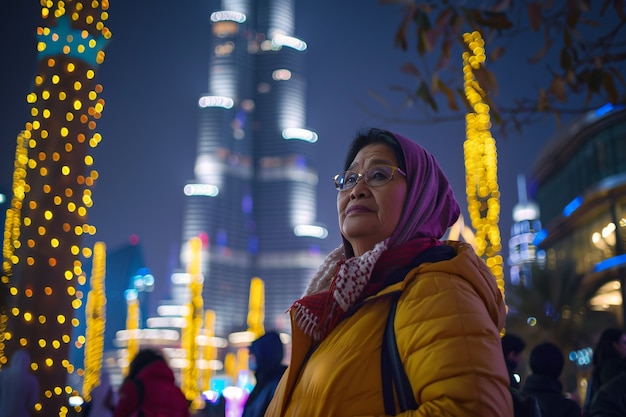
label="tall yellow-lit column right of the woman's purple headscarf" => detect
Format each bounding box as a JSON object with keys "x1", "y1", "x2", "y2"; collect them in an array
[{"x1": 463, "y1": 32, "x2": 504, "y2": 296}]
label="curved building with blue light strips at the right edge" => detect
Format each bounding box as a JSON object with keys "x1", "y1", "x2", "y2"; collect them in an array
[{"x1": 529, "y1": 105, "x2": 626, "y2": 323}]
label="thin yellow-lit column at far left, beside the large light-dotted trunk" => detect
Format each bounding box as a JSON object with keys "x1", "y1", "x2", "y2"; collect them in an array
[{"x1": 0, "y1": 132, "x2": 28, "y2": 368}]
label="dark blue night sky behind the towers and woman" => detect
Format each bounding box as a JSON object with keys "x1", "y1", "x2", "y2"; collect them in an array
[{"x1": 0, "y1": 0, "x2": 600, "y2": 312}]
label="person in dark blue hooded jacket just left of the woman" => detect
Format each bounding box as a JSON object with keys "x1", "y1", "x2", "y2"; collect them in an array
[{"x1": 242, "y1": 332, "x2": 287, "y2": 417}]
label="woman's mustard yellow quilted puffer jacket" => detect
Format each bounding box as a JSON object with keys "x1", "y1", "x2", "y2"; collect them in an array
[{"x1": 265, "y1": 242, "x2": 513, "y2": 417}]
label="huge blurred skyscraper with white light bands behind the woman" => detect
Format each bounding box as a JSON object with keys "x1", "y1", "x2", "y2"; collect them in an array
[{"x1": 181, "y1": 0, "x2": 326, "y2": 336}]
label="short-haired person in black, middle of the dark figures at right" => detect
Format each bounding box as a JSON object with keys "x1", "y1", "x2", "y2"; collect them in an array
[{"x1": 522, "y1": 343, "x2": 581, "y2": 417}]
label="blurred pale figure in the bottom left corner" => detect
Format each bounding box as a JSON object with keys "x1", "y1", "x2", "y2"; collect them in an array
[{"x1": 0, "y1": 350, "x2": 39, "y2": 417}]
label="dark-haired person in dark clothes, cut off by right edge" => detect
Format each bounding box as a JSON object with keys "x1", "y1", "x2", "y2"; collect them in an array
[{"x1": 583, "y1": 328, "x2": 626, "y2": 415}]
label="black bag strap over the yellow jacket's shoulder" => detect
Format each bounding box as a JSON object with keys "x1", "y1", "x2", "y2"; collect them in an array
[{"x1": 380, "y1": 291, "x2": 419, "y2": 416}]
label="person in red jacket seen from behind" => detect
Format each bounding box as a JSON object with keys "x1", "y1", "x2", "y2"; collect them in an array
[{"x1": 114, "y1": 349, "x2": 189, "y2": 417}]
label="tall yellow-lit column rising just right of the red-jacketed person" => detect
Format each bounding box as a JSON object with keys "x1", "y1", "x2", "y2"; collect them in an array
[{"x1": 181, "y1": 237, "x2": 203, "y2": 400}]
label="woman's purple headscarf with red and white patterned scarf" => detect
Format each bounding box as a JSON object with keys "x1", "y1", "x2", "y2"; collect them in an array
[{"x1": 290, "y1": 133, "x2": 460, "y2": 341}]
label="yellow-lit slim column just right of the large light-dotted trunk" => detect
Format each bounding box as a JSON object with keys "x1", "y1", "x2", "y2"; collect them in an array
[{"x1": 83, "y1": 242, "x2": 106, "y2": 401}]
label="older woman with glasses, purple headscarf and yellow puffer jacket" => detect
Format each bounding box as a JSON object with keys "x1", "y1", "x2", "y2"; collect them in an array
[{"x1": 266, "y1": 129, "x2": 513, "y2": 417}]
